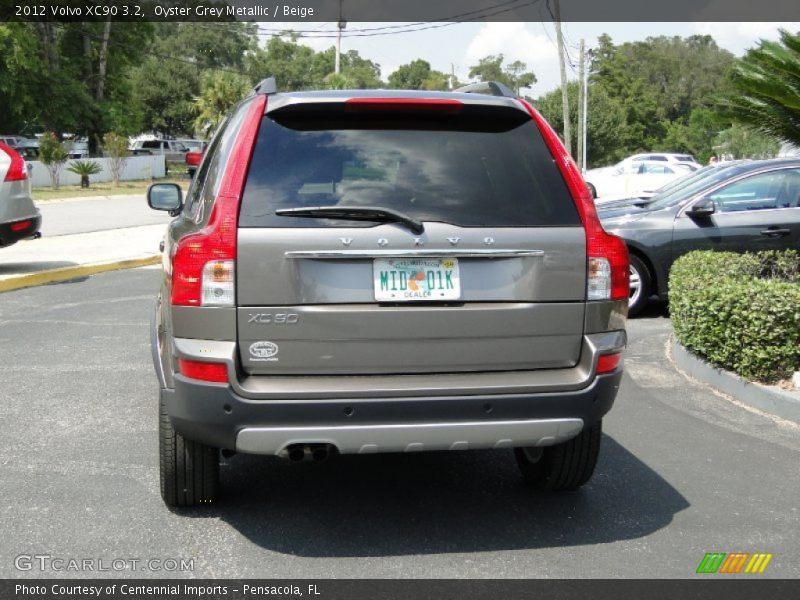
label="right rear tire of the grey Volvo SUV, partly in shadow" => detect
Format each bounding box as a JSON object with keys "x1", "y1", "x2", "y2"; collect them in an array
[{"x1": 514, "y1": 421, "x2": 602, "y2": 491}]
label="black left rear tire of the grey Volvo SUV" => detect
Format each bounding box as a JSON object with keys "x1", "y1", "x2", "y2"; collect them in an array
[{"x1": 158, "y1": 398, "x2": 219, "y2": 507}]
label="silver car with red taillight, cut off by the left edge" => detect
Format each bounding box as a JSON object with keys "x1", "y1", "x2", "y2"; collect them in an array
[{"x1": 0, "y1": 142, "x2": 42, "y2": 247}]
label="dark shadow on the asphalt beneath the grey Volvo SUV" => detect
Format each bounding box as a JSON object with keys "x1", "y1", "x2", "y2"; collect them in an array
[{"x1": 181, "y1": 435, "x2": 689, "y2": 557}]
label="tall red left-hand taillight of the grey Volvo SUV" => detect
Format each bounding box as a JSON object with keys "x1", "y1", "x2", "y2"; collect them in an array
[{"x1": 171, "y1": 96, "x2": 267, "y2": 306}]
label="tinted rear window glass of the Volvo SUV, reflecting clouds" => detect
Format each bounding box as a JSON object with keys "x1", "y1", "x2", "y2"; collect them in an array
[{"x1": 239, "y1": 106, "x2": 581, "y2": 227}]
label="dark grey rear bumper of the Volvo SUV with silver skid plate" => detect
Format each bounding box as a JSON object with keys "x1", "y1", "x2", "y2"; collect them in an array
[{"x1": 161, "y1": 369, "x2": 622, "y2": 454}]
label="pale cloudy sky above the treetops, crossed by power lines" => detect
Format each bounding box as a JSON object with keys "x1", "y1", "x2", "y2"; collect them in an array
[{"x1": 268, "y1": 22, "x2": 800, "y2": 97}]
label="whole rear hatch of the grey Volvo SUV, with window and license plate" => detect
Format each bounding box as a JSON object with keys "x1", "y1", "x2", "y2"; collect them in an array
[{"x1": 236, "y1": 96, "x2": 586, "y2": 375}]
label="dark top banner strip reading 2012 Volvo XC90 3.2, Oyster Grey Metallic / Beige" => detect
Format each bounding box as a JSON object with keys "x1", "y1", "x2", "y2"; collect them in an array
[{"x1": 0, "y1": 0, "x2": 800, "y2": 23}]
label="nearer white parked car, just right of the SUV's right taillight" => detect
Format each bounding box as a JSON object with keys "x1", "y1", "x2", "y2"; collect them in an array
[{"x1": 584, "y1": 160, "x2": 693, "y2": 199}]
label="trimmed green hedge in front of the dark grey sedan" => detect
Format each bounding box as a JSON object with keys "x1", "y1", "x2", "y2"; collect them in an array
[{"x1": 669, "y1": 250, "x2": 800, "y2": 383}]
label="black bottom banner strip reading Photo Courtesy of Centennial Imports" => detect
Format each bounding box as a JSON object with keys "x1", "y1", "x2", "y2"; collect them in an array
[{"x1": 0, "y1": 578, "x2": 800, "y2": 600}]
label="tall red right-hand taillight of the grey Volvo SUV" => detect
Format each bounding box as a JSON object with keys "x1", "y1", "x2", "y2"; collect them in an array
[{"x1": 519, "y1": 98, "x2": 630, "y2": 300}]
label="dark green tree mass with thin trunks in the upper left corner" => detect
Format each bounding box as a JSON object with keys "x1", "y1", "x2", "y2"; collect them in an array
[{"x1": 0, "y1": 21, "x2": 151, "y2": 145}]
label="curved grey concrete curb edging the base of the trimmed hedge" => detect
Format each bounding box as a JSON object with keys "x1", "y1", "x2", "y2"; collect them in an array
[{"x1": 670, "y1": 335, "x2": 800, "y2": 423}]
